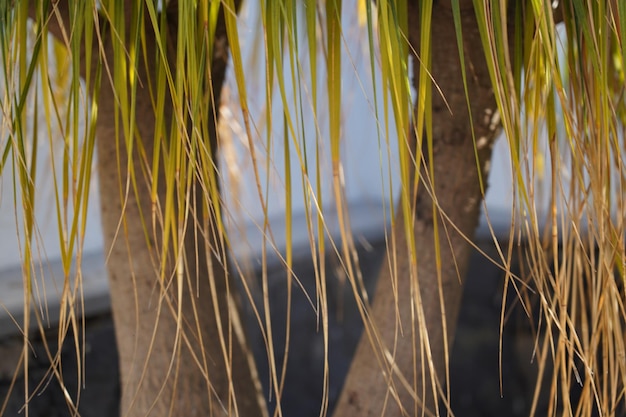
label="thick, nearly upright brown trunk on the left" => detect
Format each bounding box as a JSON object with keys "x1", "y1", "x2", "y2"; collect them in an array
[{"x1": 97, "y1": 1, "x2": 267, "y2": 417}]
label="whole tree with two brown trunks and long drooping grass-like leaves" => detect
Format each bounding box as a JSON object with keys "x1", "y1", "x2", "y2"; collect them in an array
[{"x1": 0, "y1": 0, "x2": 626, "y2": 416}]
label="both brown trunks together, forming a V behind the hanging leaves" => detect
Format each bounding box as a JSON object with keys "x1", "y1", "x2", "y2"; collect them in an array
[{"x1": 36, "y1": 1, "x2": 508, "y2": 417}]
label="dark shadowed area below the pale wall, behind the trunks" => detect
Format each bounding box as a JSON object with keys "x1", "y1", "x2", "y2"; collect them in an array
[{"x1": 0, "y1": 237, "x2": 543, "y2": 417}]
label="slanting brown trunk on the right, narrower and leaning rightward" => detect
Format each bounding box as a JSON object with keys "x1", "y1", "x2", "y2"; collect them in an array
[{"x1": 335, "y1": 1, "x2": 498, "y2": 417}]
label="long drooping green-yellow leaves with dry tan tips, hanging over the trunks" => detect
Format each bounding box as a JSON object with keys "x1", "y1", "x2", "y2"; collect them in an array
[{"x1": 0, "y1": 0, "x2": 626, "y2": 415}]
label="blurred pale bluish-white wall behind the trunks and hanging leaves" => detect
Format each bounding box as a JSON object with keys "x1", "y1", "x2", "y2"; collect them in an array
[{"x1": 0, "y1": 2, "x2": 511, "y2": 279}]
